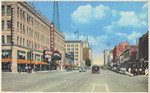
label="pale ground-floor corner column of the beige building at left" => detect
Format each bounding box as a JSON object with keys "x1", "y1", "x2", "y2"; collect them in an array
[{"x1": 12, "y1": 46, "x2": 17, "y2": 72}]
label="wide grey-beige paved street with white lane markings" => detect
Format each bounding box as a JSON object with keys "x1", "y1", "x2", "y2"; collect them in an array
[{"x1": 2, "y1": 70, "x2": 148, "y2": 92}]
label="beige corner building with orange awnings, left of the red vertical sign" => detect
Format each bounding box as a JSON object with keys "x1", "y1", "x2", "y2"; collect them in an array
[{"x1": 2, "y1": 2, "x2": 50, "y2": 72}]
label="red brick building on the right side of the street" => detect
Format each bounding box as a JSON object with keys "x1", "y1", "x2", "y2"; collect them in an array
[{"x1": 113, "y1": 40, "x2": 128, "y2": 65}]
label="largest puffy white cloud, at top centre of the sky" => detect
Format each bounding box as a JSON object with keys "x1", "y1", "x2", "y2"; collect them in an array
[{"x1": 71, "y1": 4, "x2": 109, "y2": 24}]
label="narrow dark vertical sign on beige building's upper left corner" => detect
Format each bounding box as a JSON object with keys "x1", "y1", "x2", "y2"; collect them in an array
[{"x1": 11, "y1": 8, "x2": 14, "y2": 45}]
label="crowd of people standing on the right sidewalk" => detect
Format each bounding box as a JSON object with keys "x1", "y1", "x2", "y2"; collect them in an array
[{"x1": 126, "y1": 67, "x2": 148, "y2": 76}]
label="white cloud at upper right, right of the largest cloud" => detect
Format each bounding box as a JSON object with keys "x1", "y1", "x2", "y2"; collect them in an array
[{"x1": 117, "y1": 11, "x2": 140, "y2": 27}]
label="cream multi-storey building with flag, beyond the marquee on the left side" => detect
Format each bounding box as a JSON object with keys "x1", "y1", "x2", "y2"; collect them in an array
[{"x1": 65, "y1": 40, "x2": 84, "y2": 67}]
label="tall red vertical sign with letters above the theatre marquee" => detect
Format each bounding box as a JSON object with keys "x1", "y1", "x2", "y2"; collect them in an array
[{"x1": 50, "y1": 23, "x2": 54, "y2": 50}]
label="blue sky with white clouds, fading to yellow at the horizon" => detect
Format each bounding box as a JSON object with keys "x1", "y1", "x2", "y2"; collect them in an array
[{"x1": 29, "y1": 1, "x2": 148, "y2": 64}]
